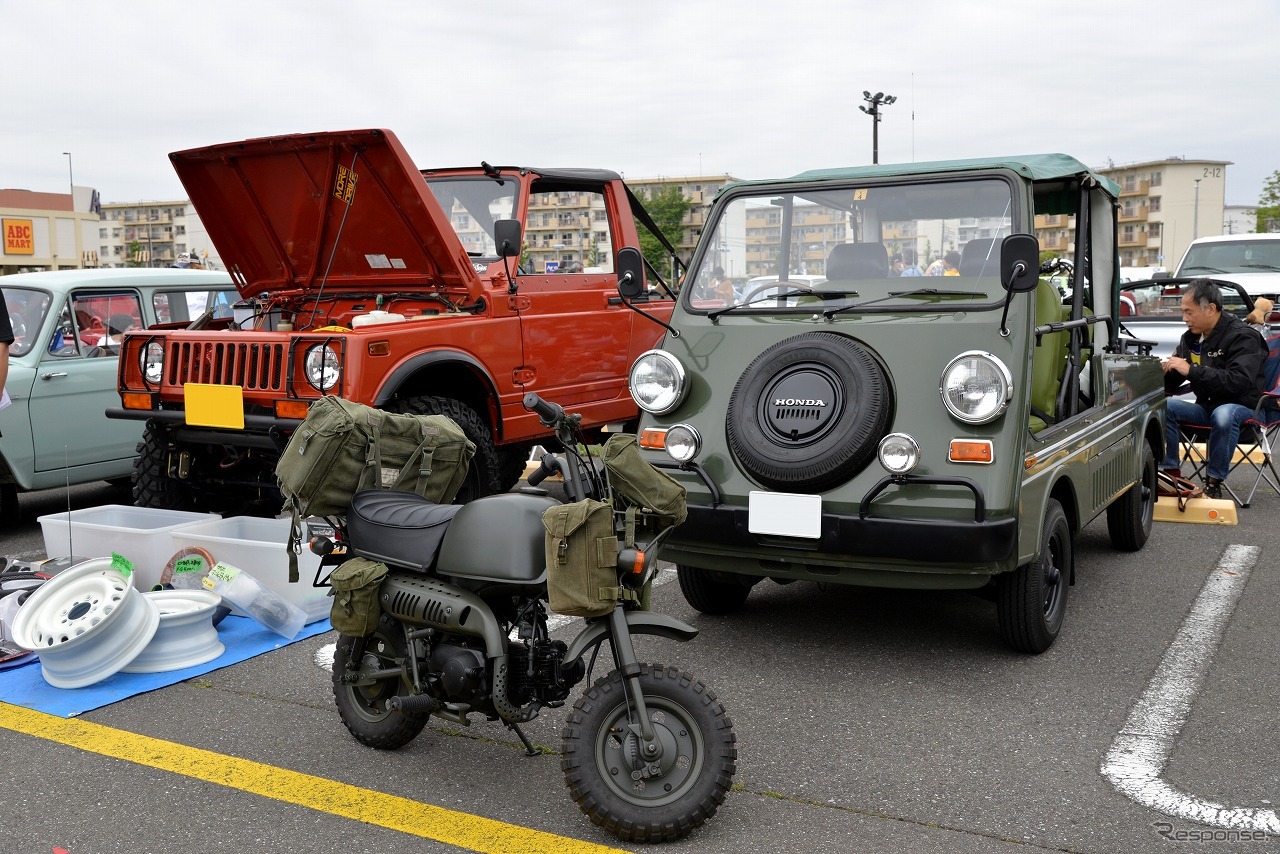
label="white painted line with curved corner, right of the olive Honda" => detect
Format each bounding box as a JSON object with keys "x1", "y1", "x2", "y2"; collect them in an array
[{"x1": 1101, "y1": 545, "x2": 1280, "y2": 835}]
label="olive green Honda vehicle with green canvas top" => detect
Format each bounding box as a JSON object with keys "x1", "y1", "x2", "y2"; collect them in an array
[{"x1": 631, "y1": 155, "x2": 1165, "y2": 653}]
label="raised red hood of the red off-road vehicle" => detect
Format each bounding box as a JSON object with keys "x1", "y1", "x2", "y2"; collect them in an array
[{"x1": 169, "y1": 129, "x2": 481, "y2": 300}]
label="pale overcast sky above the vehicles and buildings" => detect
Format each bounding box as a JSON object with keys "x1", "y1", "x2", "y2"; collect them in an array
[{"x1": 0, "y1": 0, "x2": 1280, "y2": 205}]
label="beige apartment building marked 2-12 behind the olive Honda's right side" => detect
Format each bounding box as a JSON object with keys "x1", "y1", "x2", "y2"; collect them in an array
[{"x1": 1036, "y1": 157, "x2": 1231, "y2": 270}]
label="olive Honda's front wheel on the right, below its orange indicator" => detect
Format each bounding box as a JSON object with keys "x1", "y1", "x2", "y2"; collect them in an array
[{"x1": 996, "y1": 498, "x2": 1075, "y2": 654}]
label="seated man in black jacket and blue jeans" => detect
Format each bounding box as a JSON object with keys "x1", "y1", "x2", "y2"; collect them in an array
[{"x1": 1161, "y1": 279, "x2": 1267, "y2": 498}]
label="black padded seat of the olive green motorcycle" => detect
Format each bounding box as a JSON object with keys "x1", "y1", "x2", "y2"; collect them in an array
[{"x1": 347, "y1": 489, "x2": 462, "y2": 572}]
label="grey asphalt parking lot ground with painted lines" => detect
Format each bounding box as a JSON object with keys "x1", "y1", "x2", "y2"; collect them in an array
[{"x1": 0, "y1": 478, "x2": 1280, "y2": 854}]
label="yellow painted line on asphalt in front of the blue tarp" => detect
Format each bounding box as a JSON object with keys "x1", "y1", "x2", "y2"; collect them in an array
[{"x1": 0, "y1": 703, "x2": 623, "y2": 854}]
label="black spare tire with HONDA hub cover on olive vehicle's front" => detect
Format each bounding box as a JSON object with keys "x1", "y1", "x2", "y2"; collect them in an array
[{"x1": 726, "y1": 332, "x2": 893, "y2": 492}]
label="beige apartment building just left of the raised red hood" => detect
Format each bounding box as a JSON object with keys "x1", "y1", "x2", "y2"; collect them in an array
[{"x1": 97, "y1": 200, "x2": 225, "y2": 270}]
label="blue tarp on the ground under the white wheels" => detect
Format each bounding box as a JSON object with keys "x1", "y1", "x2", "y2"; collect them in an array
[{"x1": 0, "y1": 617, "x2": 330, "y2": 717}]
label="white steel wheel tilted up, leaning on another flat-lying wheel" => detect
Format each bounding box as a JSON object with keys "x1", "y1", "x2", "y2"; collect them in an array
[{"x1": 13, "y1": 557, "x2": 160, "y2": 688}]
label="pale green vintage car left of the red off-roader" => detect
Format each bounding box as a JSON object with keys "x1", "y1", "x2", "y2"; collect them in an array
[{"x1": 0, "y1": 269, "x2": 239, "y2": 526}]
